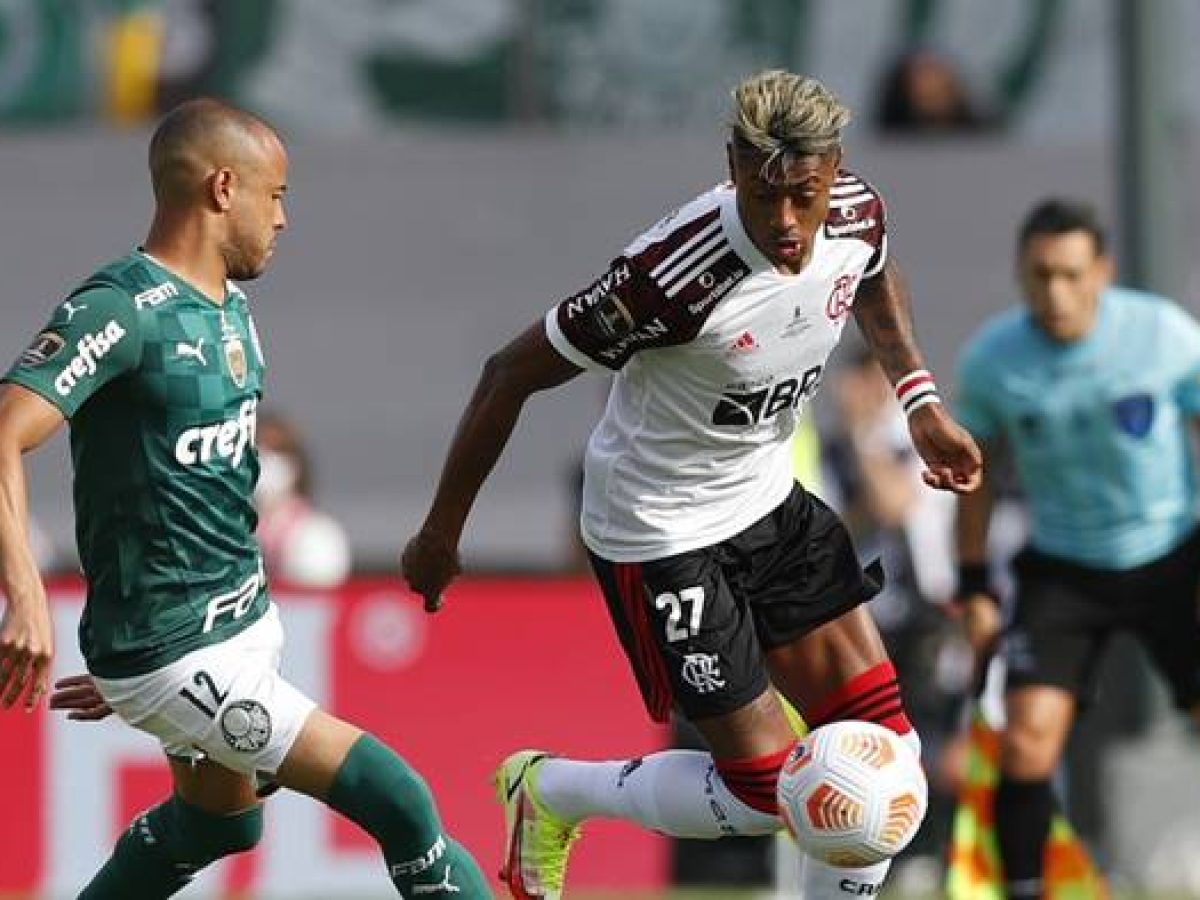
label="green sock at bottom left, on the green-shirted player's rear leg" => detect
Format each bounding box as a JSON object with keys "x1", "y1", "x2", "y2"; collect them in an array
[{"x1": 79, "y1": 796, "x2": 263, "y2": 900}]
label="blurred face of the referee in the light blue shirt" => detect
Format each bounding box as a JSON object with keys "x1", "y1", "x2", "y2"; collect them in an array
[{"x1": 1018, "y1": 230, "x2": 1112, "y2": 343}]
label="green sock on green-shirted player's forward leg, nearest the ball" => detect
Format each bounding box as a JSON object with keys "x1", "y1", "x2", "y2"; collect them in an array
[{"x1": 328, "y1": 734, "x2": 492, "y2": 900}]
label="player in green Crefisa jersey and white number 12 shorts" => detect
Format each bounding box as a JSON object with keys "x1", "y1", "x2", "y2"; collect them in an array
[{"x1": 0, "y1": 100, "x2": 491, "y2": 900}]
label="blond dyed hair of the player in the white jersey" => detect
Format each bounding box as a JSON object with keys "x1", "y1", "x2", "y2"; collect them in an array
[{"x1": 730, "y1": 68, "x2": 851, "y2": 172}]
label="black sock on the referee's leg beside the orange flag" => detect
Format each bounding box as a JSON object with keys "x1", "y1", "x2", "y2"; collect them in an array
[{"x1": 996, "y1": 775, "x2": 1054, "y2": 900}]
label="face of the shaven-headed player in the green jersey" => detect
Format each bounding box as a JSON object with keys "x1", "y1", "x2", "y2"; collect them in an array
[{"x1": 223, "y1": 134, "x2": 288, "y2": 281}]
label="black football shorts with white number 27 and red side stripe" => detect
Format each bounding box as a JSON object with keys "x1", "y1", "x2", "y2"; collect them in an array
[{"x1": 590, "y1": 485, "x2": 882, "y2": 722}]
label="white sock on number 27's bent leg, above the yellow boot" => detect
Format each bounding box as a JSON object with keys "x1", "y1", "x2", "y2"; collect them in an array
[{"x1": 538, "y1": 750, "x2": 782, "y2": 838}]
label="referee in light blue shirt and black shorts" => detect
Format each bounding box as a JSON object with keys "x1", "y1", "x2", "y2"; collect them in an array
[{"x1": 955, "y1": 200, "x2": 1200, "y2": 899}]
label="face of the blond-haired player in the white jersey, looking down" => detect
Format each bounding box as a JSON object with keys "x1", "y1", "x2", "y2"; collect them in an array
[{"x1": 728, "y1": 146, "x2": 841, "y2": 275}]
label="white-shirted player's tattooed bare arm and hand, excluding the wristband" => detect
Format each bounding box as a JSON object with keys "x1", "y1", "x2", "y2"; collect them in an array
[{"x1": 854, "y1": 259, "x2": 983, "y2": 493}]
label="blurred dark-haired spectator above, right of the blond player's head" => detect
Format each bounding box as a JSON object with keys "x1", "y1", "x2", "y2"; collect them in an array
[{"x1": 875, "y1": 47, "x2": 997, "y2": 136}]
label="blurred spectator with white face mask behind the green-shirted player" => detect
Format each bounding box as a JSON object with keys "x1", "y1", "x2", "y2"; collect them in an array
[{"x1": 254, "y1": 413, "x2": 350, "y2": 588}]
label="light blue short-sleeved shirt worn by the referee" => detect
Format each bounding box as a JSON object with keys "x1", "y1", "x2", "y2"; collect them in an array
[{"x1": 958, "y1": 288, "x2": 1200, "y2": 570}]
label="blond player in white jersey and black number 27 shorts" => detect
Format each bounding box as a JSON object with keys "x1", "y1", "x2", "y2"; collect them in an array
[{"x1": 402, "y1": 71, "x2": 980, "y2": 898}]
